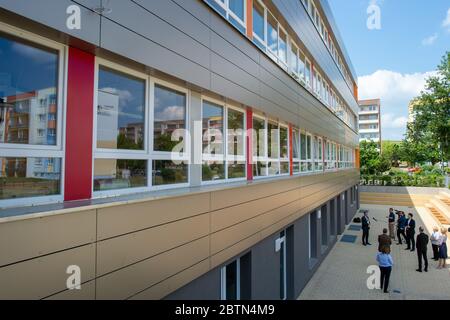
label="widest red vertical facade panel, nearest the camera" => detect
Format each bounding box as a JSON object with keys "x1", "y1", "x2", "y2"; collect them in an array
[{"x1": 64, "y1": 47, "x2": 95, "y2": 201}]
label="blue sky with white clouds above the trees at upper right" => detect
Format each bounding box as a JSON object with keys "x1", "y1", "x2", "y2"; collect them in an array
[{"x1": 328, "y1": 0, "x2": 450, "y2": 140}]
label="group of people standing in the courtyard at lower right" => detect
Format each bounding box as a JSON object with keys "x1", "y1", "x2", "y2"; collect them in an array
[{"x1": 361, "y1": 208, "x2": 448, "y2": 293}]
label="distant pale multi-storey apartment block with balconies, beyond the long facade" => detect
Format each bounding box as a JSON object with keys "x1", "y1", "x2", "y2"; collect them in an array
[{"x1": 358, "y1": 99, "x2": 381, "y2": 145}]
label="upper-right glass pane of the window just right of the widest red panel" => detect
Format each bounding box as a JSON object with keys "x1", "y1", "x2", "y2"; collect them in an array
[{"x1": 153, "y1": 85, "x2": 186, "y2": 152}]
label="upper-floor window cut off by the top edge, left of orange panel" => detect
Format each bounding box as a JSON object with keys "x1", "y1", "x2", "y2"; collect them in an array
[{"x1": 205, "y1": 0, "x2": 247, "y2": 34}]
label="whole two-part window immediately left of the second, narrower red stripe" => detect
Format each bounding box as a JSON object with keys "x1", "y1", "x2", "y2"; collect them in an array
[{"x1": 202, "y1": 100, "x2": 246, "y2": 182}]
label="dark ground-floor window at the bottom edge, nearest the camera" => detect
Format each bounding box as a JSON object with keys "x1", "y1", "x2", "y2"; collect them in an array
[{"x1": 220, "y1": 253, "x2": 251, "y2": 300}]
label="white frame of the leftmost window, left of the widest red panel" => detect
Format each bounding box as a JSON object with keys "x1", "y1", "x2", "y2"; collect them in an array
[{"x1": 0, "y1": 22, "x2": 68, "y2": 209}]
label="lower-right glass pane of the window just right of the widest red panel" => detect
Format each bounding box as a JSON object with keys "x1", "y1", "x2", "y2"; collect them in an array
[{"x1": 152, "y1": 160, "x2": 188, "y2": 186}]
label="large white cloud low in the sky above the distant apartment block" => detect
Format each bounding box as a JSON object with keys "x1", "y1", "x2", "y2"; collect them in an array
[{"x1": 358, "y1": 70, "x2": 436, "y2": 140}]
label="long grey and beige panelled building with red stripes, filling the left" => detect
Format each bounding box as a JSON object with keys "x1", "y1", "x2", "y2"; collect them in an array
[{"x1": 0, "y1": 0, "x2": 359, "y2": 300}]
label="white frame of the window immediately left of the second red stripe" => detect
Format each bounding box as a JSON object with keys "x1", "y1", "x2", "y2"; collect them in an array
[{"x1": 201, "y1": 95, "x2": 247, "y2": 185}]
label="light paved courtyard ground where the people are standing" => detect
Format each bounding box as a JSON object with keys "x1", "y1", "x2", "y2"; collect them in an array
[{"x1": 299, "y1": 204, "x2": 450, "y2": 300}]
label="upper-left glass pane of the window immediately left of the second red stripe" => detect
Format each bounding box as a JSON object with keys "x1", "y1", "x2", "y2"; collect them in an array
[{"x1": 203, "y1": 101, "x2": 224, "y2": 154}]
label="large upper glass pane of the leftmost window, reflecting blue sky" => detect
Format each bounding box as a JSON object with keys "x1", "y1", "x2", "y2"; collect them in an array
[{"x1": 0, "y1": 33, "x2": 59, "y2": 145}]
